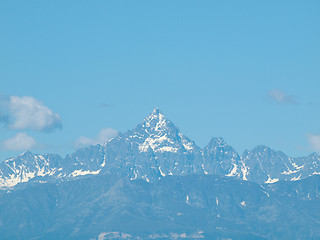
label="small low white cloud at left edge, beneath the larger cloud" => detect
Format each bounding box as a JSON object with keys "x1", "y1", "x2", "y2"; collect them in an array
[{"x1": 0, "y1": 133, "x2": 36, "y2": 151}]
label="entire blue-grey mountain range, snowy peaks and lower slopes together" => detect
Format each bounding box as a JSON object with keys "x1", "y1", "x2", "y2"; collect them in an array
[{"x1": 0, "y1": 109, "x2": 320, "y2": 240}]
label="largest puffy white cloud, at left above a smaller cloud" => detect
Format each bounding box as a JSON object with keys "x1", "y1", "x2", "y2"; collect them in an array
[{"x1": 0, "y1": 96, "x2": 62, "y2": 131}]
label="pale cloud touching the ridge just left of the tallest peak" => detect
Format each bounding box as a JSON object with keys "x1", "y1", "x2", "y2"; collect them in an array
[{"x1": 74, "y1": 128, "x2": 118, "y2": 147}]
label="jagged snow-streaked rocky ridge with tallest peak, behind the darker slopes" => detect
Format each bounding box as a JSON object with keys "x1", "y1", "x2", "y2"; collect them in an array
[{"x1": 0, "y1": 109, "x2": 320, "y2": 189}]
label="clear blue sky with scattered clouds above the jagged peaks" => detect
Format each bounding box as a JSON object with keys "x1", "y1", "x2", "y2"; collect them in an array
[{"x1": 0, "y1": 0, "x2": 320, "y2": 160}]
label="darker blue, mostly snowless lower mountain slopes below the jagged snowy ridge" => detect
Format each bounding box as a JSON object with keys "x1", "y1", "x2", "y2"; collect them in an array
[{"x1": 0, "y1": 174, "x2": 320, "y2": 239}]
